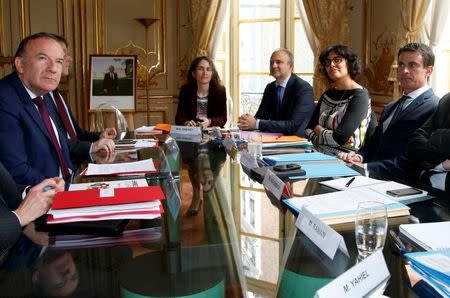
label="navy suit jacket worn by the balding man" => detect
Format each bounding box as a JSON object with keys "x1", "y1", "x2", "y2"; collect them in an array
[{"x1": 255, "y1": 74, "x2": 314, "y2": 137}]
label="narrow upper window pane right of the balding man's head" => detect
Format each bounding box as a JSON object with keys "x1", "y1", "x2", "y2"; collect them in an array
[{"x1": 294, "y1": 20, "x2": 314, "y2": 73}]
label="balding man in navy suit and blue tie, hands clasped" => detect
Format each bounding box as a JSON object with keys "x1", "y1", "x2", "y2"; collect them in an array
[{"x1": 239, "y1": 49, "x2": 314, "y2": 137}]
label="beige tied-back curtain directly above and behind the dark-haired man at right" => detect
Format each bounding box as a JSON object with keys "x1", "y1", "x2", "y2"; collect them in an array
[{"x1": 388, "y1": 0, "x2": 430, "y2": 99}]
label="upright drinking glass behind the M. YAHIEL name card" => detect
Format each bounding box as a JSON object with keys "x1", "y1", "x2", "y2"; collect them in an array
[{"x1": 355, "y1": 201, "x2": 388, "y2": 260}]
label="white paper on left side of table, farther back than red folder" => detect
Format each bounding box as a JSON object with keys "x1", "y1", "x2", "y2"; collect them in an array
[{"x1": 85, "y1": 158, "x2": 156, "y2": 176}]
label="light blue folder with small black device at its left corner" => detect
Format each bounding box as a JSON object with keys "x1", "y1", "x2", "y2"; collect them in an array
[{"x1": 289, "y1": 163, "x2": 360, "y2": 179}]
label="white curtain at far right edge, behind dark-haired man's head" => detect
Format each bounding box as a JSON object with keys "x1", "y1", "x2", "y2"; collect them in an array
[{"x1": 425, "y1": 0, "x2": 450, "y2": 96}]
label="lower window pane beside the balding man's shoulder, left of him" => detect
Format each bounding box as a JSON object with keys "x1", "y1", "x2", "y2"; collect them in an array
[{"x1": 239, "y1": 75, "x2": 274, "y2": 115}]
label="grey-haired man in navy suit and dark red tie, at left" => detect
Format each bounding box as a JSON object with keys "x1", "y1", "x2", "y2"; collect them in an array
[{"x1": 0, "y1": 32, "x2": 74, "y2": 185}]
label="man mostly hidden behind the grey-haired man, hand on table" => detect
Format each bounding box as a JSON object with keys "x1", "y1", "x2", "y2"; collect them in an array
[{"x1": 44, "y1": 35, "x2": 117, "y2": 162}]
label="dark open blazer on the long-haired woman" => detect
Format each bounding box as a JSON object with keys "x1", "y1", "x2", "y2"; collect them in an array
[{"x1": 175, "y1": 83, "x2": 227, "y2": 127}]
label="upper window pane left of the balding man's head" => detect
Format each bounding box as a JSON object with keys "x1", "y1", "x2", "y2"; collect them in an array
[{"x1": 239, "y1": 22, "x2": 280, "y2": 72}]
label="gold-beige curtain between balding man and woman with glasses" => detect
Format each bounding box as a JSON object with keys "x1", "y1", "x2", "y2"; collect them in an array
[{"x1": 303, "y1": 0, "x2": 351, "y2": 99}]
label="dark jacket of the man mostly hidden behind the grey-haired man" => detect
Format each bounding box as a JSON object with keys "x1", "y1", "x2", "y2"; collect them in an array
[{"x1": 44, "y1": 91, "x2": 101, "y2": 162}]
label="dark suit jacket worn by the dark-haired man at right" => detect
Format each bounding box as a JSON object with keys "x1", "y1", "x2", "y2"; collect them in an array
[{"x1": 359, "y1": 89, "x2": 439, "y2": 180}]
